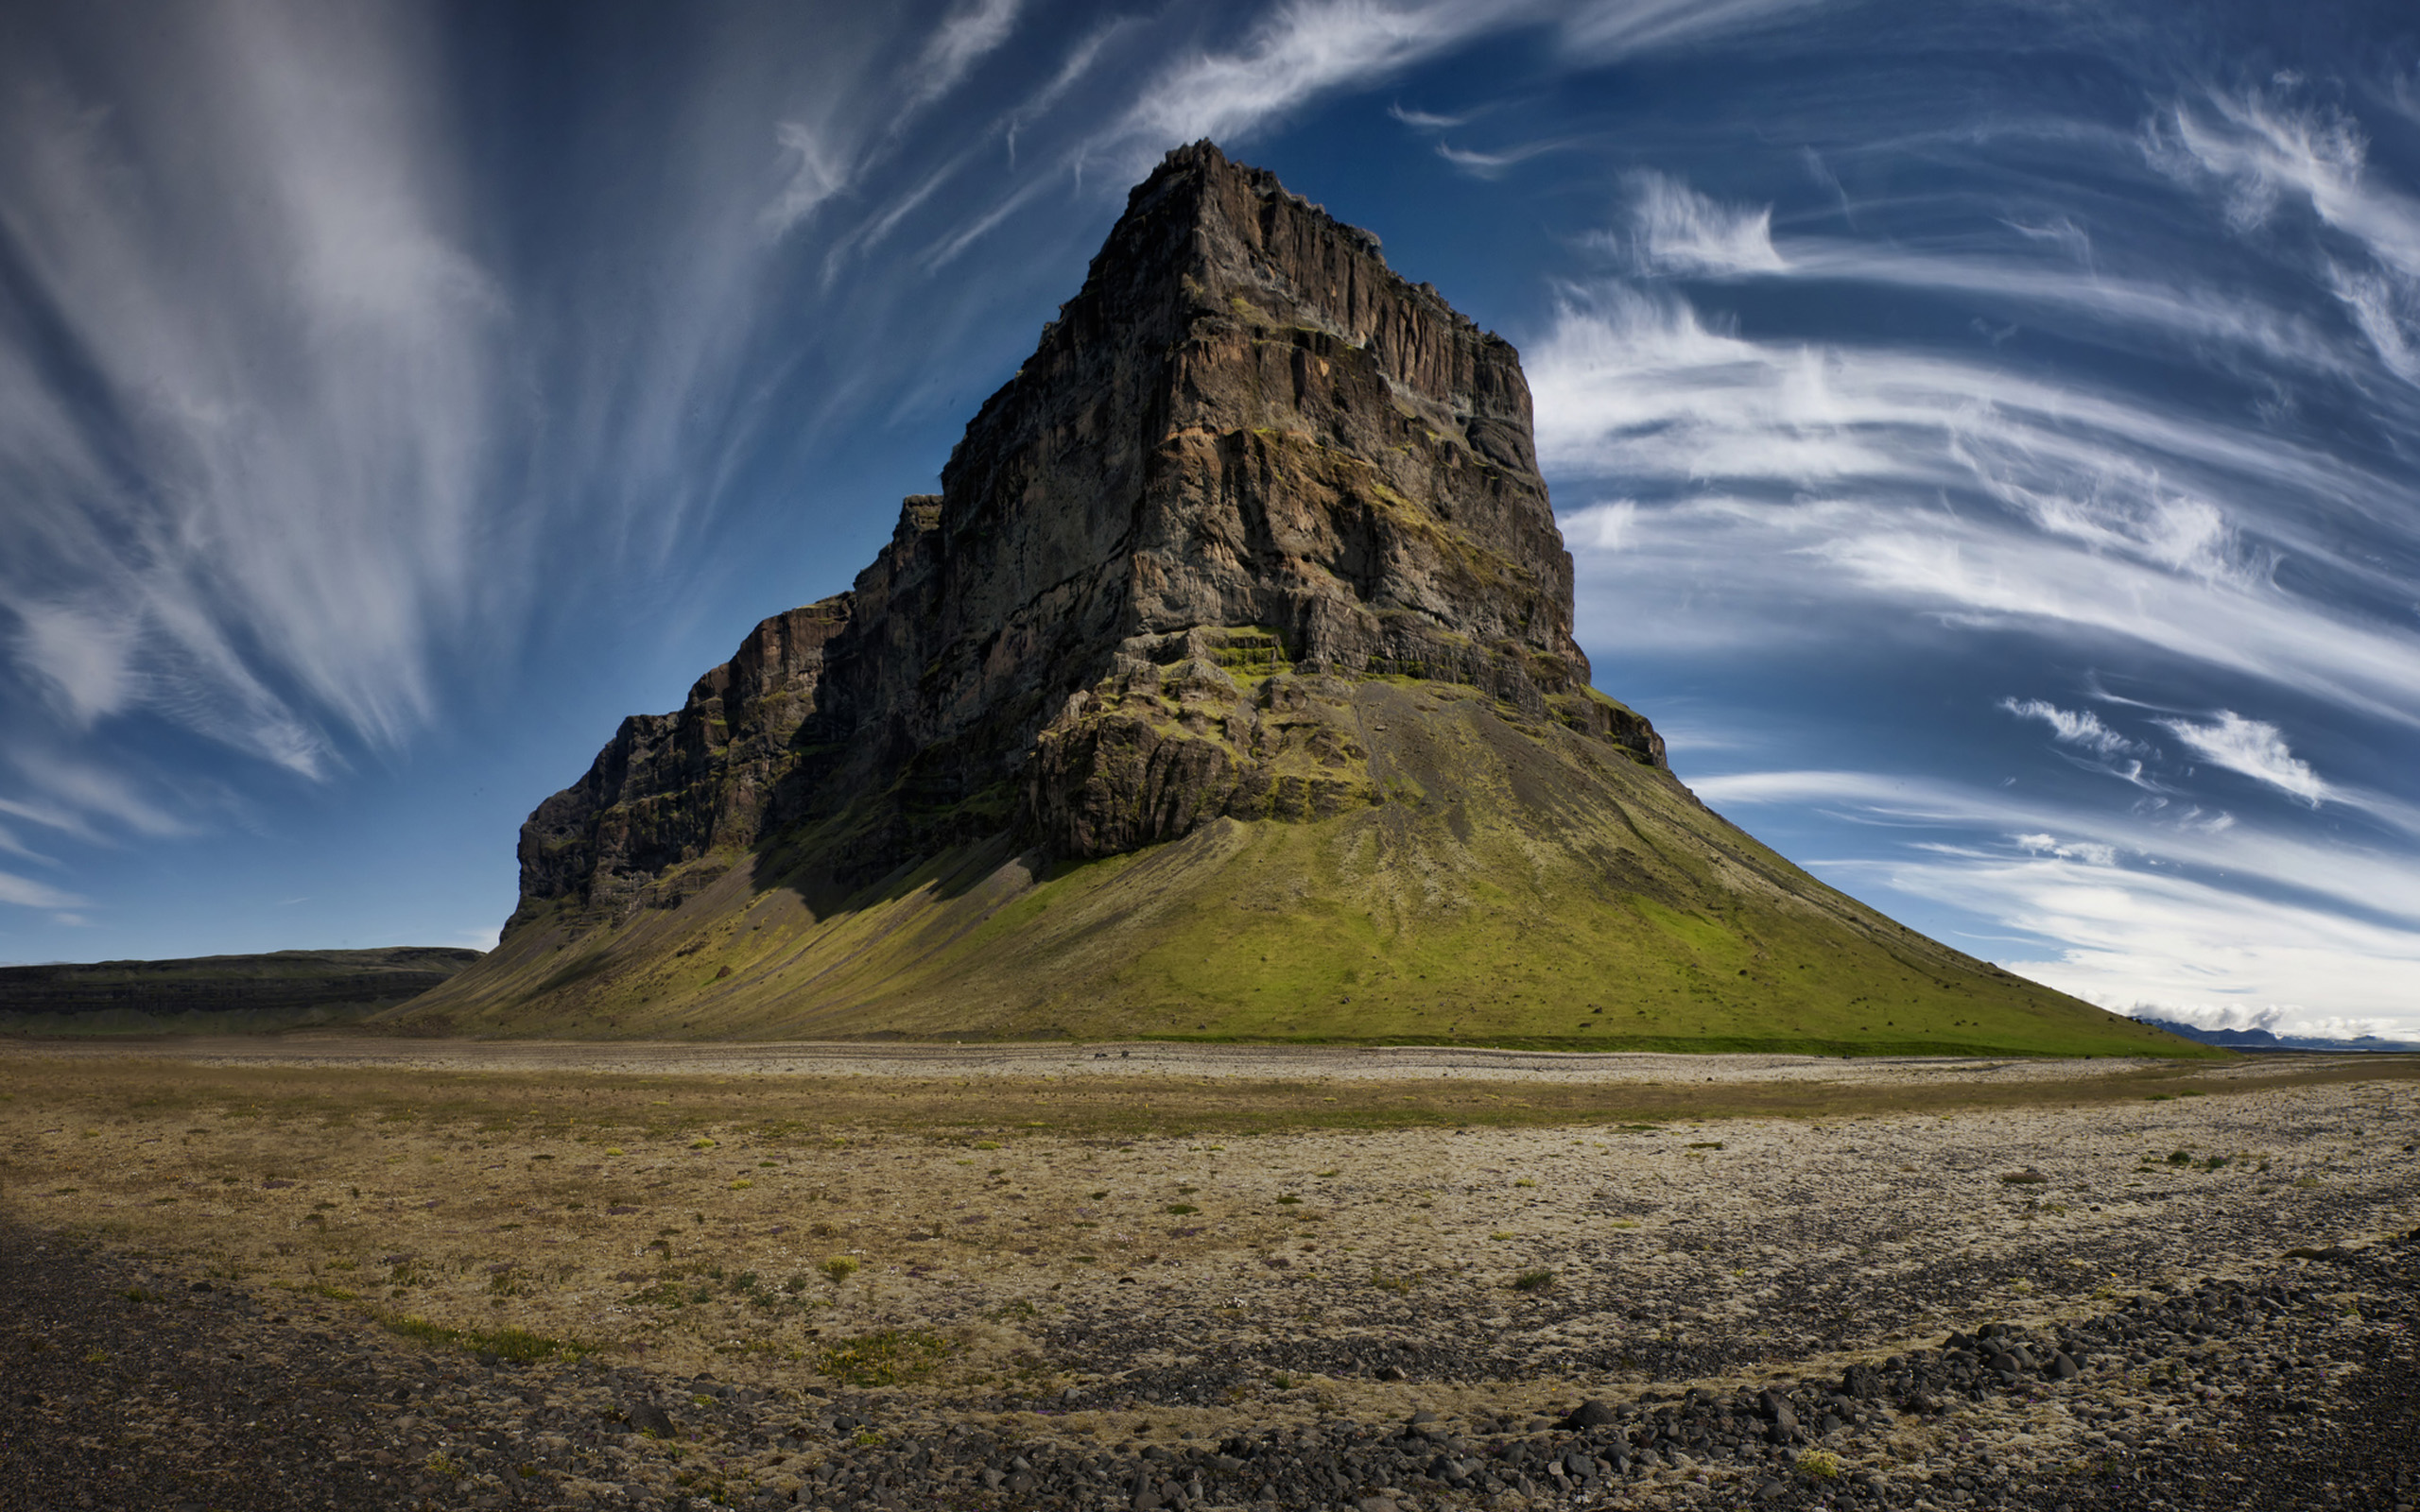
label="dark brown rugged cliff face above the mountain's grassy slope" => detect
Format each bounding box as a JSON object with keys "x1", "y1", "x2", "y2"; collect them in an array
[{"x1": 515, "y1": 143, "x2": 1663, "y2": 924}]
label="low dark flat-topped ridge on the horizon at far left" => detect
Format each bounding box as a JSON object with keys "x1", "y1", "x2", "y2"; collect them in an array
[{"x1": 0, "y1": 946, "x2": 479, "y2": 1033}]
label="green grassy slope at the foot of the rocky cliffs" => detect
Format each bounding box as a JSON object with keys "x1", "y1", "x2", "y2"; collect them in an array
[{"x1": 406, "y1": 679, "x2": 2207, "y2": 1055}]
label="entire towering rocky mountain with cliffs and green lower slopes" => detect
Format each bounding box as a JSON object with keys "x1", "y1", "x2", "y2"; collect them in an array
[{"x1": 409, "y1": 143, "x2": 2204, "y2": 1055}]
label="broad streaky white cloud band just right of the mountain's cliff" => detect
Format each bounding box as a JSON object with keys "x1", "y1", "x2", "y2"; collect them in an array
[{"x1": 1525, "y1": 285, "x2": 2420, "y2": 723}]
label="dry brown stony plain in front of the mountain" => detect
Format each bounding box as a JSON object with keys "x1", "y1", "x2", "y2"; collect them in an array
[{"x1": 0, "y1": 1038, "x2": 2420, "y2": 1507}]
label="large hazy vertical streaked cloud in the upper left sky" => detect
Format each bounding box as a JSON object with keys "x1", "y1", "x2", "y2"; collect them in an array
[{"x1": 0, "y1": 5, "x2": 509, "y2": 774}]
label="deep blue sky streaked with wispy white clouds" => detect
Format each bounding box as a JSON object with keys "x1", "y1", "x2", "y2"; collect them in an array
[{"x1": 0, "y1": 0, "x2": 2420, "y2": 1033}]
